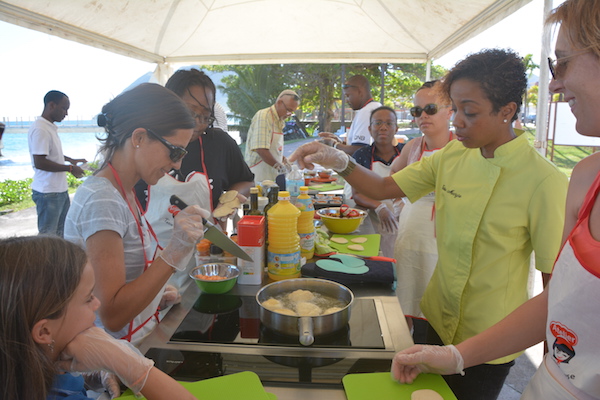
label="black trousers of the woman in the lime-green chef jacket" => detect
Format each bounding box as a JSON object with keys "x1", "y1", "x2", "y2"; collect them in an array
[{"x1": 427, "y1": 325, "x2": 515, "y2": 400}]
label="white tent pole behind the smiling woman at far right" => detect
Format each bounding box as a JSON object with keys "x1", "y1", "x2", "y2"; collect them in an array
[{"x1": 533, "y1": 0, "x2": 552, "y2": 156}]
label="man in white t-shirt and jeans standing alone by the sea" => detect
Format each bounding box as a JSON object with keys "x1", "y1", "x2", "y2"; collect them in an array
[{"x1": 27, "y1": 90, "x2": 86, "y2": 237}]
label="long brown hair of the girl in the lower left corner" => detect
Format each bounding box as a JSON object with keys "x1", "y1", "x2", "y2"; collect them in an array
[{"x1": 0, "y1": 236, "x2": 87, "y2": 399}]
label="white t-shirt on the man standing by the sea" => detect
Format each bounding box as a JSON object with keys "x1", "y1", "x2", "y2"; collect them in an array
[{"x1": 27, "y1": 117, "x2": 68, "y2": 193}]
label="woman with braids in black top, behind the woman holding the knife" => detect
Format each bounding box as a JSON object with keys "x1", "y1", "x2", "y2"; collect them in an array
[{"x1": 135, "y1": 68, "x2": 254, "y2": 291}]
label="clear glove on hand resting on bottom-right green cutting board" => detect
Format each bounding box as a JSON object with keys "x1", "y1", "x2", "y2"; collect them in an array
[{"x1": 392, "y1": 345, "x2": 465, "y2": 383}]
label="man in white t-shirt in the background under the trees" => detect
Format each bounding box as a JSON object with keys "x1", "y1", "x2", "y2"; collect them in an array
[{"x1": 319, "y1": 75, "x2": 381, "y2": 155}]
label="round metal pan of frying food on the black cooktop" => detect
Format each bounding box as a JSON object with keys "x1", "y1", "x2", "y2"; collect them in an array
[{"x1": 256, "y1": 278, "x2": 354, "y2": 346}]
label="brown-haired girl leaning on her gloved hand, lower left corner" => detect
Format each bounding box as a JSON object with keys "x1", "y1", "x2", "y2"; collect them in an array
[{"x1": 0, "y1": 236, "x2": 194, "y2": 400}]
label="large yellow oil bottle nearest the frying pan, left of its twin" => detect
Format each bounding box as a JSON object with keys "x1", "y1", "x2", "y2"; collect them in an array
[{"x1": 267, "y1": 191, "x2": 300, "y2": 281}]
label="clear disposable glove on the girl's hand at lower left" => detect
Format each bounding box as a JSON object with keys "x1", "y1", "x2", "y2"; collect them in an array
[{"x1": 56, "y1": 327, "x2": 154, "y2": 394}]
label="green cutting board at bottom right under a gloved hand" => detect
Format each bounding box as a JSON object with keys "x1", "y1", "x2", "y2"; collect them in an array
[{"x1": 342, "y1": 372, "x2": 457, "y2": 400}]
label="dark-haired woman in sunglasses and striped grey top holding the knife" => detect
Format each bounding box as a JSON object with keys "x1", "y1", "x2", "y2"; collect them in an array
[{"x1": 65, "y1": 84, "x2": 209, "y2": 341}]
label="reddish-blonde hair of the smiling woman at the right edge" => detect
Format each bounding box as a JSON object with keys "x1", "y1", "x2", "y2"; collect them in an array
[{"x1": 546, "y1": 0, "x2": 600, "y2": 57}]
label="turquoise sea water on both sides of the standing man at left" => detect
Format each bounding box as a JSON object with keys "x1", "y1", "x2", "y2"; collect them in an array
[{"x1": 0, "y1": 128, "x2": 102, "y2": 182}]
